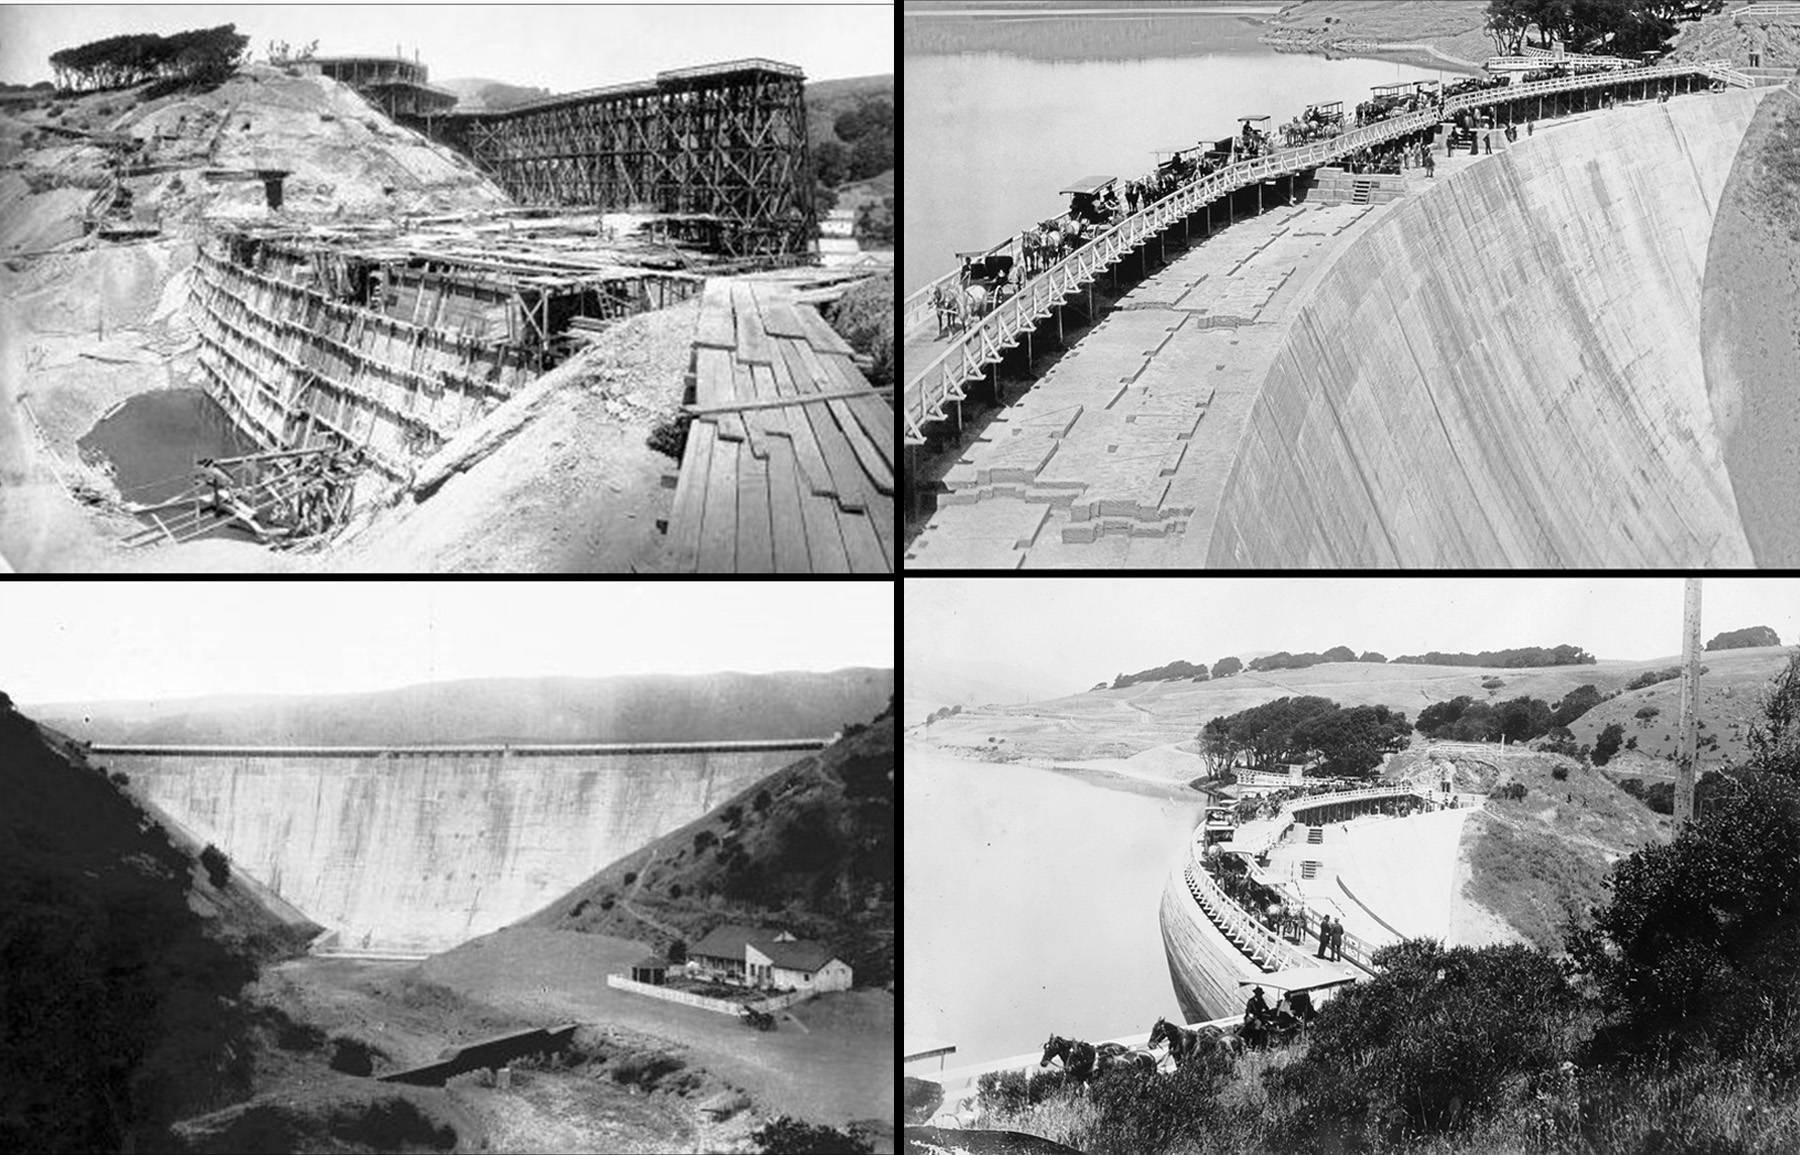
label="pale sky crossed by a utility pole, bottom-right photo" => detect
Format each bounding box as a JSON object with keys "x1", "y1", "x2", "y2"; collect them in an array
[{"x1": 905, "y1": 578, "x2": 1800, "y2": 693}]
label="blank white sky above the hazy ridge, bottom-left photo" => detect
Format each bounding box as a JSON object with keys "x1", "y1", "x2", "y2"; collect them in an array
[{"x1": 0, "y1": 581, "x2": 895, "y2": 705}]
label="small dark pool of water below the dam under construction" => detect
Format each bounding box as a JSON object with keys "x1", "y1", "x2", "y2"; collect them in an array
[{"x1": 76, "y1": 389, "x2": 259, "y2": 540}]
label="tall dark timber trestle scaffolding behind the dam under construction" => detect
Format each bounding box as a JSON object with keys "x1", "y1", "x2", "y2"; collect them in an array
[{"x1": 432, "y1": 59, "x2": 814, "y2": 263}]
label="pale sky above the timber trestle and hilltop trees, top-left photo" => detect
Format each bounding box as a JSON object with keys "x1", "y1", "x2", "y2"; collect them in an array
[{"x1": 0, "y1": 4, "x2": 895, "y2": 92}]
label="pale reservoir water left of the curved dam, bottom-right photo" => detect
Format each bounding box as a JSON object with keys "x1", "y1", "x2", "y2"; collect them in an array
[{"x1": 904, "y1": 745, "x2": 1204, "y2": 1067}]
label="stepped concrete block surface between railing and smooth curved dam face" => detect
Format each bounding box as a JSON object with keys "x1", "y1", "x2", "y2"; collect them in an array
[{"x1": 907, "y1": 205, "x2": 1391, "y2": 569}]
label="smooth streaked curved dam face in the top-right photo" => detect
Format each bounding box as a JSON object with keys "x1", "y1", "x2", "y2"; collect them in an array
[{"x1": 1193, "y1": 92, "x2": 1768, "y2": 567}]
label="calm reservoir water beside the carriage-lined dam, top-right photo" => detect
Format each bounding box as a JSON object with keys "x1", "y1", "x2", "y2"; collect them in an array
[{"x1": 904, "y1": 11, "x2": 1454, "y2": 293}]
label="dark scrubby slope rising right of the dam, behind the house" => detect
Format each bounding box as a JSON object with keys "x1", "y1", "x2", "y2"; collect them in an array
[{"x1": 524, "y1": 701, "x2": 895, "y2": 986}]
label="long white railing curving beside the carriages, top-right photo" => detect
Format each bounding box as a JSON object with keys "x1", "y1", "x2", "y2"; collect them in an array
[{"x1": 904, "y1": 61, "x2": 1751, "y2": 444}]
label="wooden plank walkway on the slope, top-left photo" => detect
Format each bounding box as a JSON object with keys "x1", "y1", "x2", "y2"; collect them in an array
[{"x1": 670, "y1": 279, "x2": 895, "y2": 574}]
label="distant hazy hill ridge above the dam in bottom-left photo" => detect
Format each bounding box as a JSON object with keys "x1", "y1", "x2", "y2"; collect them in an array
[{"x1": 24, "y1": 667, "x2": 893, "y2": 745}]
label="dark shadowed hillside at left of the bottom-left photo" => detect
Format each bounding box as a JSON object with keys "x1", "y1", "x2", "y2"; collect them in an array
[{"x1": 0, "y1": 694, "x2": 308, "y2": 1151}]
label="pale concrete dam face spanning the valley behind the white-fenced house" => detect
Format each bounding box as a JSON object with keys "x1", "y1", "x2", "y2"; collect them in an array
[{"x1": 92, "y1": 739, "x2": 828, "y2": 954}]
